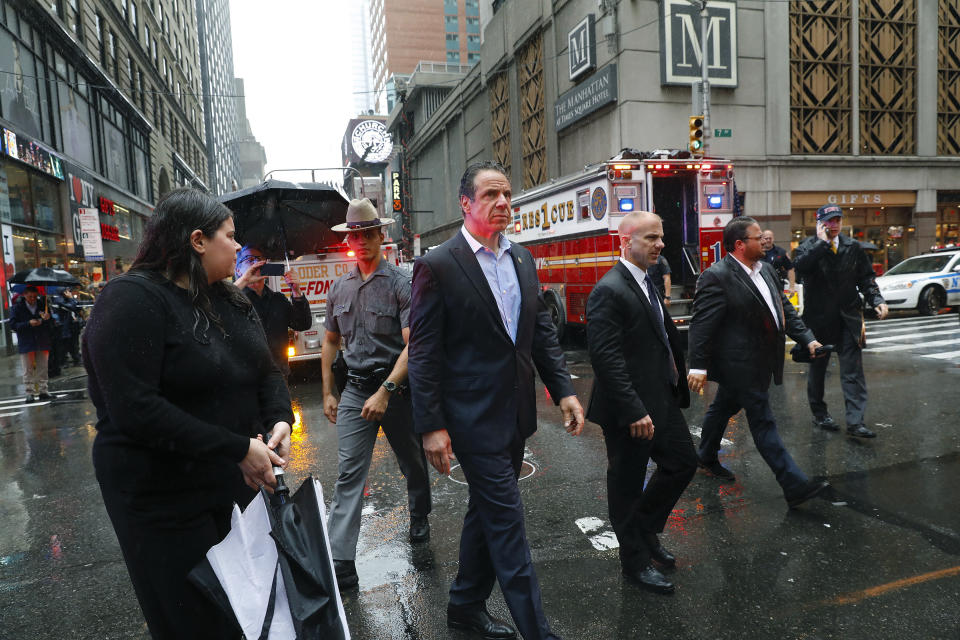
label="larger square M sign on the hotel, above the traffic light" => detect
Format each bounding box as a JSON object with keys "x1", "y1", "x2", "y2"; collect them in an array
[{"x1": 660, "y1": 0, "x2": 737, "y2": 87}]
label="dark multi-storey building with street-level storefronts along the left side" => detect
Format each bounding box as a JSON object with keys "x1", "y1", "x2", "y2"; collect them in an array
[{"x1": 0, "y1": 0, "x2": 221, "y2": 350}]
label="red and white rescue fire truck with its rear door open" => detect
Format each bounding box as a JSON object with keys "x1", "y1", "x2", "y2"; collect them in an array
[{"x1": 507, "y1": 149, "x2": 739, "y2": 337}]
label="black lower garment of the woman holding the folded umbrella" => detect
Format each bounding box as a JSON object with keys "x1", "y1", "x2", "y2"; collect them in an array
[{"x1": 100, "y1": 483, "x2": 241, "y2": 640}]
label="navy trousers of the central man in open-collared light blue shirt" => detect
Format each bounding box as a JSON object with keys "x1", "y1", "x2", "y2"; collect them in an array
[{"x1": 450, "y1": 436, "x2": 559, "y2": 640}]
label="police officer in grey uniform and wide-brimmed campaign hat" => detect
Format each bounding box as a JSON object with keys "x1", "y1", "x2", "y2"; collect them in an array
[{"x1": 322, "y1": 198, "x2": 430, "y2": 589}]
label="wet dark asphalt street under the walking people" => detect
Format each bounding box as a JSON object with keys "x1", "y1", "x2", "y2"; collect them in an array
[{"x1": 0, "y1": 316, "x2": 960, "y2": 640}]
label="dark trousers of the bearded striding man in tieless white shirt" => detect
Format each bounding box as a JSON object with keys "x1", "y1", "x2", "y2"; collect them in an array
[{"x1": 697, "y1": 384, "x2": 810, "y2": 497}]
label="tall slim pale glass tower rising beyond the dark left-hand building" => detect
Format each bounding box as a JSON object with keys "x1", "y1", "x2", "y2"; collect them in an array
[{"x1": 195, "y1": 0, "x2": 243, "y2": 194}]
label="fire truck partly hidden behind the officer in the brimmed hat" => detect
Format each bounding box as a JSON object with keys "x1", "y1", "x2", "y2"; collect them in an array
[{"x1": 267, "y1": 244, "x2": 400, "y2": 366}]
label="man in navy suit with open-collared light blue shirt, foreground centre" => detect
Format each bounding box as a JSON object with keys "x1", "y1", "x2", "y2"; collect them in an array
[{"x1": 408, "y1": 162, "x2": 583, "y2": 640}]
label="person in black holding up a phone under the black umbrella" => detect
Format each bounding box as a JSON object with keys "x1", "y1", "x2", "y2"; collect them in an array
[{"x1": 234, "y1": 245, "x2": 313, "y2": 376}]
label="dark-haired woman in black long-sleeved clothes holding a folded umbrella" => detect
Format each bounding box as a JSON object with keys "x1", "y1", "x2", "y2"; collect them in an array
[{"x1": 83, "y1": 190, "x2": 293, "y2": 640}]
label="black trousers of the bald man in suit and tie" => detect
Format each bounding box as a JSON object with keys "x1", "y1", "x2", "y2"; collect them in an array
[{"x1": 603, "y1": 400, "x2": 697, "y2": 571}]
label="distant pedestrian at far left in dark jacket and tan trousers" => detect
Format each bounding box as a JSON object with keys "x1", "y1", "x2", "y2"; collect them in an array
[{"x1": 10, "y1": 284, "x2": 52, "y2": 402}]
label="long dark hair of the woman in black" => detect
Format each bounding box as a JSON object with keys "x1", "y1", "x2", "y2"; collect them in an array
[{"x1": 130, "y1": 189, "x2": 251, "y2": 342}]
